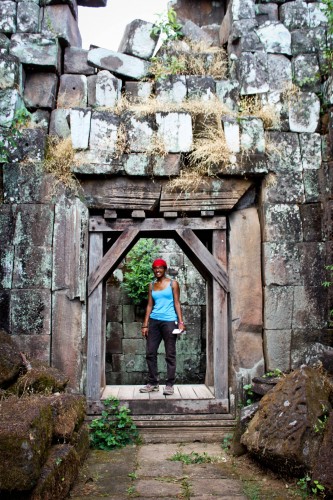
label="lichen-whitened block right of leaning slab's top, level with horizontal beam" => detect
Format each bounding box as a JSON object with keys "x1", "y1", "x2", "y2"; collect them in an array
[{"x1": 263, "y1": 203, "x2": 303, "y2": 242}]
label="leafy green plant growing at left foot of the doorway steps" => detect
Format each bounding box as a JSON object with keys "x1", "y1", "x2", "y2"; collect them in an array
[{"x1": 90, "y1": 397, "x2": 138, "y2": 450}]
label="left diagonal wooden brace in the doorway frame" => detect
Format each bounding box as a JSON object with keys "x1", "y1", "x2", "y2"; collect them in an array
[{"x1": 88, "y1": 227, "x2": 139, "y2": 295}]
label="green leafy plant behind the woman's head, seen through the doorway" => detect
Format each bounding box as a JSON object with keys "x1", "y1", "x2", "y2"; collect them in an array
[{"x1": 121, "y1": 238, "x2": 159, "y2": 305}]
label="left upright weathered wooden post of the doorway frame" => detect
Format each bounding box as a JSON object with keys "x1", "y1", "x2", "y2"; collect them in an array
[{"x1": 87, "y1": 233, "x2": 105, "y2": 402}]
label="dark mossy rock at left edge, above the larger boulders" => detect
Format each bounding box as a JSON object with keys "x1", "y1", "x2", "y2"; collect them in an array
[{"x1": 0, "y1": 330, "x2": 22, "y2": 387}]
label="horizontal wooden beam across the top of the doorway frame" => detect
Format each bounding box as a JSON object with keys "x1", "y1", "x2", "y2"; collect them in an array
[{"x1": 89, "y1": 215, "x2": 226, "y2": 232}]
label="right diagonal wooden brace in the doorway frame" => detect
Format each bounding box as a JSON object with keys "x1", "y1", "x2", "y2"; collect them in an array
[{"x1": 176, "y1": 229, "x2": 229, "y2": 292}]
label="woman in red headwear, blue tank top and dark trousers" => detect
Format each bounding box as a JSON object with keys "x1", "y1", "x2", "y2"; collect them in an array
[{"x1": 140, "y1": 259, "x2": 185, "y2": 396}]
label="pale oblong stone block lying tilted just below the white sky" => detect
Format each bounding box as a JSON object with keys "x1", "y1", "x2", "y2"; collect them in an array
[{"x1": 88, "y1": 48, "x2": 150, "y2": 80}]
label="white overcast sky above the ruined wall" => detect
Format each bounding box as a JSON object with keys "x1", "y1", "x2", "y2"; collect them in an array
[{"x1": 79, "y1": 0, "x2": 168, "y2": 50}]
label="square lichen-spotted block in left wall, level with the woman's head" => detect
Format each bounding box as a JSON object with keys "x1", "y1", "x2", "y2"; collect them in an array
[{"x1": 12, "y1": 246, "x2": 52, "y2": 288}]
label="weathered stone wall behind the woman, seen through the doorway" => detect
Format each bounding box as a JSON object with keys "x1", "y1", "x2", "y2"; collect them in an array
[{"x1": 106, "y1": 239, "x2": 206, "y2": 385}]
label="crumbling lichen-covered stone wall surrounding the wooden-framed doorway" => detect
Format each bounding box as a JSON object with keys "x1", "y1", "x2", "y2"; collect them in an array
[{"x1": 0, "y1": 0, "x2": 333, "y2": 402}]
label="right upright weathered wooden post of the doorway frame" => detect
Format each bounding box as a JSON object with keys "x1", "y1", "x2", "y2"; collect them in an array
[{"x1": 212, "y1": 231, "x2": 228, "y2": 400}]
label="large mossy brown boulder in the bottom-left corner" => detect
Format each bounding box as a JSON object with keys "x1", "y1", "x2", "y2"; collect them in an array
[{"x1": 0, "y1": 398, "x2": 52, "y2": 491}]
